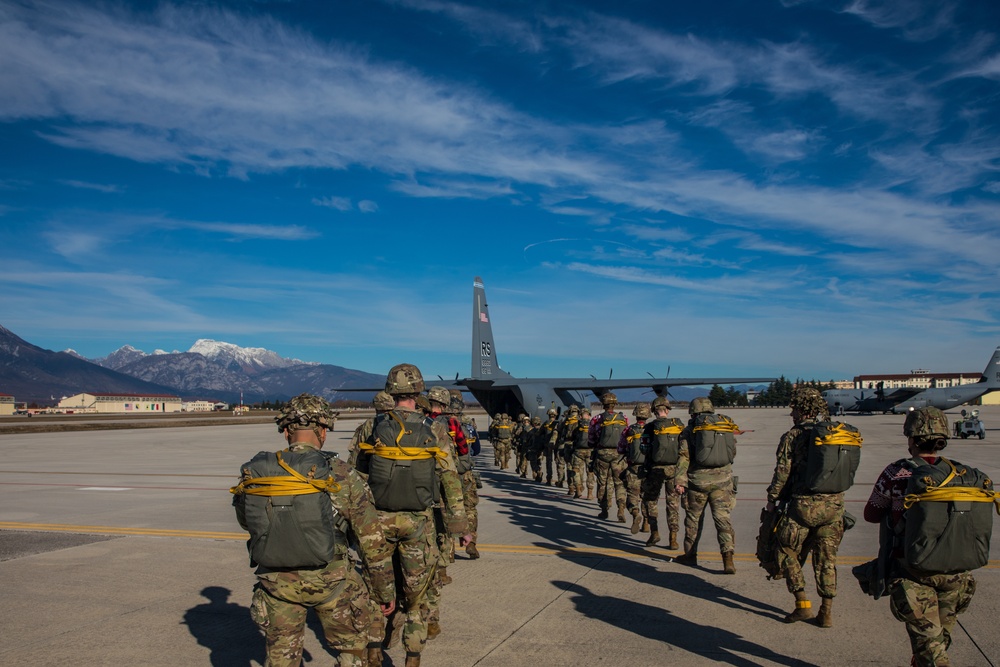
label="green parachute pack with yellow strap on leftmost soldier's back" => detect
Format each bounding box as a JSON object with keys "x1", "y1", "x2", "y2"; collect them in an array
[{"x1": 230, "y1": 447, "x2": 347, "y2": 570}]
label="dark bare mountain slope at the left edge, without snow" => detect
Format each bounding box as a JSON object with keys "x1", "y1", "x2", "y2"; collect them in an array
[{"x1": 0, "y1": 326, "x2": 184, "y2": 405}]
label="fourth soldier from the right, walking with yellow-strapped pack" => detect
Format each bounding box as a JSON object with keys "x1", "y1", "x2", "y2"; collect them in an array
[{"x1": 642, "y1": 396, "x2": 688, "y2": 549}]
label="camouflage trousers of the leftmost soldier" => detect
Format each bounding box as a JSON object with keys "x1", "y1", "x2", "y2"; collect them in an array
[{"x1": 250, "y1": 558, "x2": 373, "y2": 667}]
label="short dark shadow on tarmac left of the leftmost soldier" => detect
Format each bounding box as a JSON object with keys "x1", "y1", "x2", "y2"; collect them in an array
[{"x1": 182, "y1": 586, "x2": 265, "y2": 667}]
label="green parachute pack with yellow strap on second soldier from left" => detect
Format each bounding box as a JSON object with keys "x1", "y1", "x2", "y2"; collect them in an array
[{"x1": 362, "y1": 410, "x2": 446, "y2": 512}]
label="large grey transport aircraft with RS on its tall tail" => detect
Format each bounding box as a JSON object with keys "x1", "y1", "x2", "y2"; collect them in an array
[{"x1": 340, "y1": 276, "x2": 774, "y2": 420}]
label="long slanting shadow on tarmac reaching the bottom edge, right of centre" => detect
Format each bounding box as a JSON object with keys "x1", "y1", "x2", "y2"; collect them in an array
[{"x1": 552, "y1": 581, "x2": 817, "y2": 667}]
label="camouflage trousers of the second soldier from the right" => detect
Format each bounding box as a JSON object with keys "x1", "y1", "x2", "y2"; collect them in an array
[{"x1": 777, "y1": 493, "x2": 844, "y2": 598}]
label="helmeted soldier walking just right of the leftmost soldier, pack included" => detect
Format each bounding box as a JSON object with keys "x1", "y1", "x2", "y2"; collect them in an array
[{"x1": 358, "y1": 364, "x2": 471, "y2": 667}]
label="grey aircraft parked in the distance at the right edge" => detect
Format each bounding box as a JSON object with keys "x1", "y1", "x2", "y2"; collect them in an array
[{"x1": 823, "y1": 347, "x2": 1000, "y2": 414}]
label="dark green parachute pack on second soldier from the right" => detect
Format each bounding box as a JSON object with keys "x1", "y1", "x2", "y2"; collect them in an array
[{"x1": 802, "y1": 421, "x2": 864, "y2": 493}]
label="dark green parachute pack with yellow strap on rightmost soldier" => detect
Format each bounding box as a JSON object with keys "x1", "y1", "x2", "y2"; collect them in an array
[{"x1": 903, "y1": 457, "x2": 1000, "y2": 574}]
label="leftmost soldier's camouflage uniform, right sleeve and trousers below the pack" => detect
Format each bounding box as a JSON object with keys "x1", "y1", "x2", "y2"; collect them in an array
[{"x1": 240, "y1": 443, "x2": 396, "y2": 667}]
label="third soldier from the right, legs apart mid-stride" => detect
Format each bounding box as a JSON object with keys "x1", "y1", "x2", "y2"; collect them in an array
[{"x1": 674, "y1": 396, "x2": 738, "y2": 574}]
